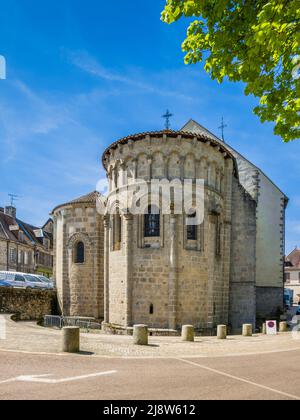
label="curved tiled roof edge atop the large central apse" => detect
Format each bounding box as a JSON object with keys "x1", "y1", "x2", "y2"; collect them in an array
[{"x1": 102, "y1": 127, "x2": 235, "y2": 169}]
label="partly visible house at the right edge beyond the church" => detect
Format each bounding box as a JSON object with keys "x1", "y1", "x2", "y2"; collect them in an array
[{"x1": 285, "y1": 247, "x2": 300, "y2": 304}]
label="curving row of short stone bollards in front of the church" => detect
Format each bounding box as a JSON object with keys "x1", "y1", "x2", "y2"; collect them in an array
[{"x1": 62, "y1": 322, "x2": 288, "y2": 353}]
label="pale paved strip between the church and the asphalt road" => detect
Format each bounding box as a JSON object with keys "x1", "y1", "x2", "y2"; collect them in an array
[{"x1": 0, "y1": 316, "x2": 300, "y2": 358}]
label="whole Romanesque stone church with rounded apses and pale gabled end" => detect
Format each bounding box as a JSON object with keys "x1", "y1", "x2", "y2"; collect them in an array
[{"x1": 52, "y1": 120, "x2": 288, "y2": 333}]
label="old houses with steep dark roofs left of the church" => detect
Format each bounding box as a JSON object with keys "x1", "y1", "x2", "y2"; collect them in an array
[{"x1": 0, "y1": 206, "x2": 53, "y2": 277}]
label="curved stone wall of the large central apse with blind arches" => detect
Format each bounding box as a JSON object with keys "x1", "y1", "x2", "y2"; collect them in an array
[{"x1": 107, "y1": 136, "x2": 234, "y2": 329}]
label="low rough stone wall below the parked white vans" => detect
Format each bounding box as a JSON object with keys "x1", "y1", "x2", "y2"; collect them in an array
[{"x1": 0, "y1": 288, "x2": 57, "y2": 321}]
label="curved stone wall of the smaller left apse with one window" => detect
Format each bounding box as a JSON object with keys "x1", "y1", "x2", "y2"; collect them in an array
[{"x1": 54, "y1": 204, "x2": 104, "y2": 319}]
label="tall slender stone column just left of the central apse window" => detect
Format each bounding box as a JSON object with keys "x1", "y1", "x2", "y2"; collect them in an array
[{"x1": 123, "y1": 212, "x2": 133, "y2": 327}]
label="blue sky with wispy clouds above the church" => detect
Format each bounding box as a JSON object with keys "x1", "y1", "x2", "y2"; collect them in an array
[{"x1": 0, "y1": 0, "x2": 300, "y2": 251}]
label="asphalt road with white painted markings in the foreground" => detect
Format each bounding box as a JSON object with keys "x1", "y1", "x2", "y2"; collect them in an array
[{"x1": 0, "y1": 351, "x2": 300, "y2": 401}]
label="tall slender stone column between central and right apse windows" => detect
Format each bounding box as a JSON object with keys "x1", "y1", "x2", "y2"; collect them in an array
[{"x1": 169, "y1": 214, "x2": 178, "y2": 330}]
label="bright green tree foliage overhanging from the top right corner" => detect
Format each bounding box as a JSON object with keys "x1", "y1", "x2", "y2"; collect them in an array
[{"x1": 162, "y1": 0, "x2": 300, "y2": 142}]
